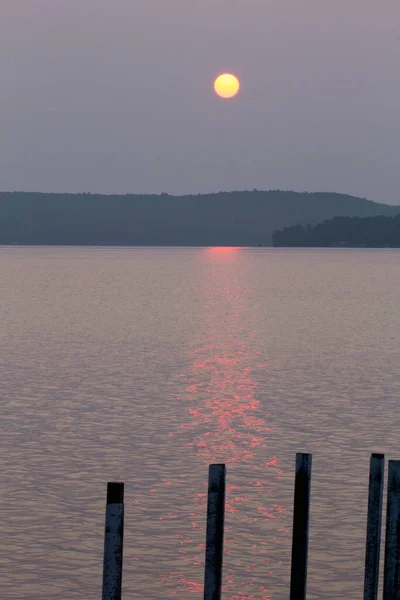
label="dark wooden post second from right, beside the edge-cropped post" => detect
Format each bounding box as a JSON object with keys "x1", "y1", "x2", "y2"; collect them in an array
[{"x1": 364, "y1": 454, "x2": 385, "y2": 600}]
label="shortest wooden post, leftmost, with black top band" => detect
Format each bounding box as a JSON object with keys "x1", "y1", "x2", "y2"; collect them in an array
[{"x1": 102, "y1": 483, "x2": 124, "y2": 600}]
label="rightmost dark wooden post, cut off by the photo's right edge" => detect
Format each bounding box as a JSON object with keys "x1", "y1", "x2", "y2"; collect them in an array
[{"x1": 383, "y1": 460, "x2": 400, "y2": 600}]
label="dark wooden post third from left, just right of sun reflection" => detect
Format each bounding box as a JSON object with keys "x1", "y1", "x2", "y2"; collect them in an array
[{"x1": 290, "y1": 454, "x2": 312, "y2": 600}]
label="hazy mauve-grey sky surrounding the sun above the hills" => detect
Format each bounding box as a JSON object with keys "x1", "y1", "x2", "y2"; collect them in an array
[{"x1": 0, "y1": 0, "x2": 400, "y2": 204}]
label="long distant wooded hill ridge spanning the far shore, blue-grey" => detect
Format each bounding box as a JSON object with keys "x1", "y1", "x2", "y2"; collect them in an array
[{"x1": 0, "y1": 190, "x2": 400, "y2": 246}]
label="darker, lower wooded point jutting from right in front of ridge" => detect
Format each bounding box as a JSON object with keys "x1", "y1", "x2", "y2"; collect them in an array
[{"x1": 272, "y1": 215, "x2": 400, "y2": 248}]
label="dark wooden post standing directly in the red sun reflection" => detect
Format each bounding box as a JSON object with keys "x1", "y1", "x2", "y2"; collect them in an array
[{"x1": 204, "y1": 465, "x2": 226, "y2": 600}]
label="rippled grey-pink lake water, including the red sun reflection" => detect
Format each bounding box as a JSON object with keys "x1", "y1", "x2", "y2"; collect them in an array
[{"x1": 0, "y1": 247, "x2": 400, "y2": 600}]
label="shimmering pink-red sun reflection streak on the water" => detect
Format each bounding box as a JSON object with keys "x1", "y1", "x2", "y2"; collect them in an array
[{"x1": 164, "y1": 248, "x2": 288, "y2": 600}]
